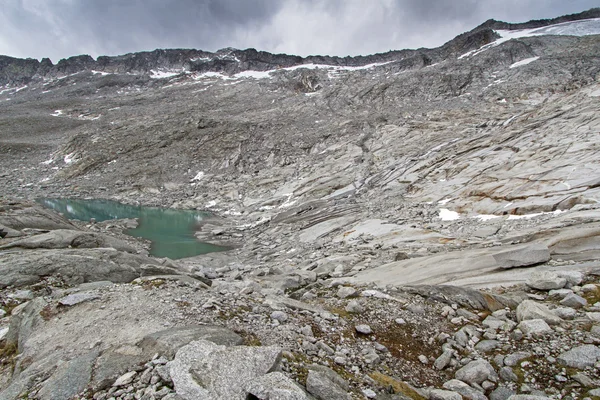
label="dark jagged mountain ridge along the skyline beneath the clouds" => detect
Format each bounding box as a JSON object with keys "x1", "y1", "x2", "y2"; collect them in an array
[{"x1": 0, "y1": 8, "x2": 600, "y2": 85}]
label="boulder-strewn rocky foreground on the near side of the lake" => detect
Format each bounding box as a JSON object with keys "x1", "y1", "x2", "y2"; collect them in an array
[{"x1": 0, "y1": 203, "x2": 600, "y2": 400}]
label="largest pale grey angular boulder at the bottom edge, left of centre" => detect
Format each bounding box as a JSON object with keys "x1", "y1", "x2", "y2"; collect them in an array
[{"x1": 167, "y1": 340, "x2": 281, "y2": 400}]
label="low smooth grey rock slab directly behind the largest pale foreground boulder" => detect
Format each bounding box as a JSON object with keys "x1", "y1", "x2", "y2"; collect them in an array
[{"x1": 138, "y1": 325, "x2": 244, "y2": 358}]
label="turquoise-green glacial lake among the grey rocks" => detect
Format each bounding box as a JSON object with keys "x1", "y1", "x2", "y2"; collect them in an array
[{"x1": 38, "y1": 199, "x2": 228, "y2": 260}]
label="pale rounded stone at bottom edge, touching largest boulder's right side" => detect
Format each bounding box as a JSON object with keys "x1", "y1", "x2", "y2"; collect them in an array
[{"x1": 247, "y1": 372, "x2": 310, "y2": 400}]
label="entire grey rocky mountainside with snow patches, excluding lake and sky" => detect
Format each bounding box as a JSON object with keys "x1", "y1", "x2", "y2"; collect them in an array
[{"x1": 0, "y1": 9, "x2": 600, "y2": 400}]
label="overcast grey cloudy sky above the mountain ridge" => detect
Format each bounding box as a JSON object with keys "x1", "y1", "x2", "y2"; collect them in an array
[{"x1": 0, "y1": 0, "x2": 600, "y2": 62}]
